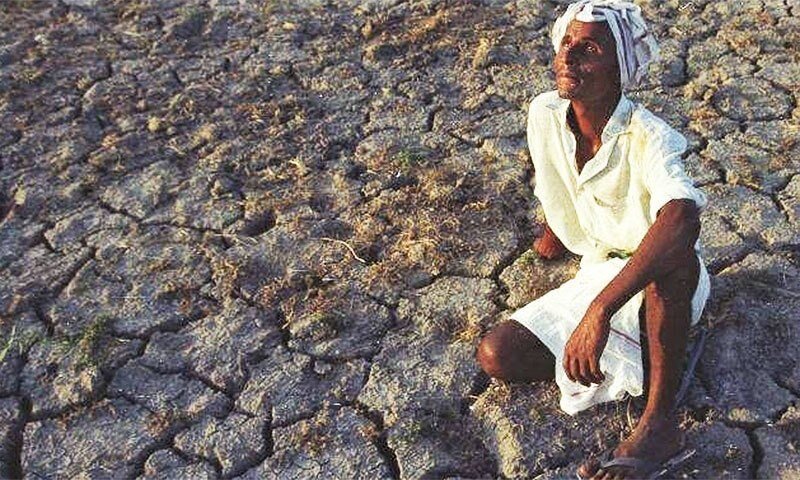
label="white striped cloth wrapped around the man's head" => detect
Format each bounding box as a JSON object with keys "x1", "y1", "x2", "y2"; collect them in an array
[{"x1": 551, "y1": 0, "x2": 658, "y2": 87}]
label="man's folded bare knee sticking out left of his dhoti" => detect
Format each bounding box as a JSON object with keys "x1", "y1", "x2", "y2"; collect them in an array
[{"x1": 476, "y1": 320, "x2": 555, "y2": 382}]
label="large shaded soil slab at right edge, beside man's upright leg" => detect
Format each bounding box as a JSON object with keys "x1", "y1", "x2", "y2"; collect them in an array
[{"x1": 700, "y1": 253, "x2": 800, "y2": 425}]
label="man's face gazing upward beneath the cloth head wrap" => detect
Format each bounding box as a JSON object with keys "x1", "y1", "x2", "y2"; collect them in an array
[{"x1": 553, "y1": 20, "x2": 620, "y2": 101}]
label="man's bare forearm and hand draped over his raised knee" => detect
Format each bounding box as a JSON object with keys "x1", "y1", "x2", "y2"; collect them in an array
[{"x1": 564, "y1": 199, "x2": 700, "y2": 385}]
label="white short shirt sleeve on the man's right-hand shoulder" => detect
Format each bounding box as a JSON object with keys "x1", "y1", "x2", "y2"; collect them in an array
[{"x1": 644, "y1": 132, "x2": 708, "y2": 220}]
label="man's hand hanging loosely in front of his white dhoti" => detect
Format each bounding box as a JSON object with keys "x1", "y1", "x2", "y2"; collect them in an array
[{"x1": 563, "y1": 303, "x2": 611, "y2": 387}]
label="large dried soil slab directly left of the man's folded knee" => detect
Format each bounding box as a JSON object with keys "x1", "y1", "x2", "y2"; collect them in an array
[{"x1": 359, "y1": 277, "x2": 496, "y2": 425}]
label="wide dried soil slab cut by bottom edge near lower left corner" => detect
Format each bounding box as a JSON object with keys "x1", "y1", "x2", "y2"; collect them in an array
[{"x1": 22, "y1": 400, "x2": 177, "y2": 479}]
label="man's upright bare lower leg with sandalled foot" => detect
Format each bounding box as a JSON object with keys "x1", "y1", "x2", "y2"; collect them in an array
[{"x1": 580, "y1": 252, "x2": 700, "y2": 480}]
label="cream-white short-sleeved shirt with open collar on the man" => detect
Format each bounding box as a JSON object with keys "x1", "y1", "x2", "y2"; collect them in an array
[{"x1": 528, "y1": 92, "x2": 707, "y2": 263}]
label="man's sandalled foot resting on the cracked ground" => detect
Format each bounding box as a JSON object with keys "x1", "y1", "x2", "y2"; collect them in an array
[{"x1": 578, "y1": 417, "x2": 683, "y2": 480}]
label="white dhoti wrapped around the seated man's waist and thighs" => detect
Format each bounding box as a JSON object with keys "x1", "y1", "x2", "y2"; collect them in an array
[{"x1": 511, "y1": 256, "x2": 711, "y2": 415}]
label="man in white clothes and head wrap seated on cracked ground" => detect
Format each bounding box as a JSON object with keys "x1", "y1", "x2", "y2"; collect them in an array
[{"x1": 477, "y1": 0, "x2": 709, "y2": 479}]
